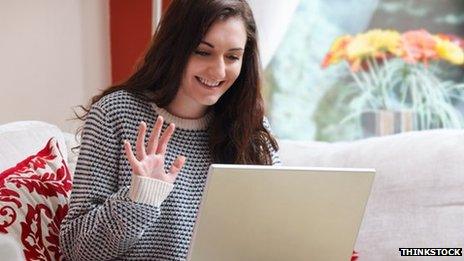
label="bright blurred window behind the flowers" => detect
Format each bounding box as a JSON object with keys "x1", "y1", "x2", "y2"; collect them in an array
[{"x1": 265, "y1": 0, "x2": 464, "y2": 141}]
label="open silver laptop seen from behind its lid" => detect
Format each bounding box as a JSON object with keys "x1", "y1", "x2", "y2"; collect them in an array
[{"x1": 187, "y1": 164, "x2": 375, "y2": 261}]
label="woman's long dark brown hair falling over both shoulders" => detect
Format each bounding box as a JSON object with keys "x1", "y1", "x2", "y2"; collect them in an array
[{"x1": 78, "y1": 0, "x2": 278, "y2": 165}]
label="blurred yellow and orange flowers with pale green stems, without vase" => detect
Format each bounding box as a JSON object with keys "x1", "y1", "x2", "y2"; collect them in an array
[{"x1": 322, "y1": 29, "x2": 464, "y2": 129}]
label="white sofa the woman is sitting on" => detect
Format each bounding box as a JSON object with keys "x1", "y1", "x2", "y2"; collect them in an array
[{"x1": 0, "y1": 122, "x2": 464, "y2": 260}]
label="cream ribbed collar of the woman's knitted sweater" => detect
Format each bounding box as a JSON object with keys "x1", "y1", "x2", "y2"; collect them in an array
[{"x1": 151, "y1": 103, "x2": 213, "y2": 130}]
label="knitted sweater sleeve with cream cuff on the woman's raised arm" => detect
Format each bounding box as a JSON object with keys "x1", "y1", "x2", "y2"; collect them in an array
[{"x1": 60, "y1": 104, "x2": 172, "y2": 260}]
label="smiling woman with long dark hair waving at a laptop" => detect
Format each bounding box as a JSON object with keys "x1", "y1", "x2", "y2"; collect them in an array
[{"x1": 60, "y1": 0, "x2": 279, "y2": 260}]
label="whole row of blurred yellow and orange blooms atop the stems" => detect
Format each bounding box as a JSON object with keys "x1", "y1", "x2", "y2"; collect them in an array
[{"x1": 321, "y1": 29, "x2": 464, "y2": 72}]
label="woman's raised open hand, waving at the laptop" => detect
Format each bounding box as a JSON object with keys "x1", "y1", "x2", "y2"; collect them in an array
[{"x1": 124, "y1": 116, "x2": 185, "y2": 184}]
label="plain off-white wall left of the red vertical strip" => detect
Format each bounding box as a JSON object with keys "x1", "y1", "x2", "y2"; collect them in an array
[{"x1": 0, "y1": 0, "x2": 111, "y2": 131}]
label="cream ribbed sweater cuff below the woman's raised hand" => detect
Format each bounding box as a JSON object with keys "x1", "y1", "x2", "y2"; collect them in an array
[{"x1": 129, "y1": 174, "x2": 174, "y2": 207}]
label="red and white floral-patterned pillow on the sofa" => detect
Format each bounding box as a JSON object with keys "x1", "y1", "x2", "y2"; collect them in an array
[{"x1": 0, "y1": 138, "x2": 72, "y2": 260}]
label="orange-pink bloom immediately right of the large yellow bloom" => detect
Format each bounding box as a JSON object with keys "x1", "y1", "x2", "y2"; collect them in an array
[{"x1": 401, "y1": 29, "x2": 437, "y2": 65}]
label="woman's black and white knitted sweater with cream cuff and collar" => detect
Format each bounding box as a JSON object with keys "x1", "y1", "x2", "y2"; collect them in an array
[{"x1": 60, "y1": 91, "x2": 280, "y2": 260}]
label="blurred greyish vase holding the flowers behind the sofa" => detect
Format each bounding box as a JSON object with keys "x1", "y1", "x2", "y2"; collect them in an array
[{"x1": 361, "y1": 110, "x2": 416, "y2": 138}]
